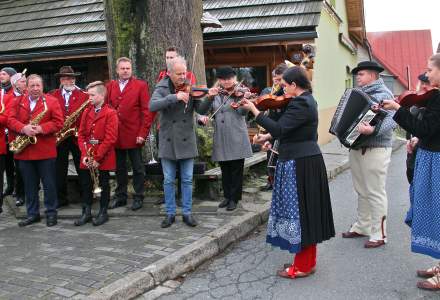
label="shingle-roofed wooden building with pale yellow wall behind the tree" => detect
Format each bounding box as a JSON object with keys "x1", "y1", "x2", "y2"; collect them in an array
[{"x1": 0, "y1": 0, "x2": 366, "y2": 142}]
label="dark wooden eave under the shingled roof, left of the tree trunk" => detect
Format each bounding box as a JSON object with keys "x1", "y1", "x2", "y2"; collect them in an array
[{"x1": 0, "y1": 44, "x2": 107, "y2": 64}]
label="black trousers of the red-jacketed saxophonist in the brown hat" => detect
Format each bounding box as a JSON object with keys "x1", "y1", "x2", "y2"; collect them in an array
[{"x1": 56, "y1": 136, "x2": 81, "y2": 205}]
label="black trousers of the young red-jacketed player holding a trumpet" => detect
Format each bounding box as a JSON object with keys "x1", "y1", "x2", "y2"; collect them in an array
[{"x1": 79, "y1": 169, "x2": 110, "y2": 208}]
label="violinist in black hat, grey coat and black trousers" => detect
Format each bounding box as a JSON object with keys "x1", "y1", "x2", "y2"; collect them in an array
[{"x1": 201, "y1": 66, "x2": 252, "y2": 210}]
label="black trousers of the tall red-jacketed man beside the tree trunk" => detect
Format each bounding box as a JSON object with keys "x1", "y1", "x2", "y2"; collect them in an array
[{"x1": 115, "y1": 148, "x2": 145, "y2": 201}]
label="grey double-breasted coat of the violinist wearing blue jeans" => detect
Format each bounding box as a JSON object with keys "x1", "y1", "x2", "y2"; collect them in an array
[{"x1": 150, "y1": 77, "x2": 205, "y2": 160}]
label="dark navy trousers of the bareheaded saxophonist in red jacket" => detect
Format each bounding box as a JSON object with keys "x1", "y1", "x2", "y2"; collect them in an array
[{"x1": 18, "y1": 158, "x2": 58, "y2": 217}]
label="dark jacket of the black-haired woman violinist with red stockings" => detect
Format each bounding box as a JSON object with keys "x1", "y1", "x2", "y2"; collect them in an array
[{"x1": 256, "y1": 92, "x2": 321, "y2": 161}]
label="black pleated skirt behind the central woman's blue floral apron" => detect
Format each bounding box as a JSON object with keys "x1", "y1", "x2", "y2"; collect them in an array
[{"x1": 295, "y1": 154, "x2": 335, "y2": 247}]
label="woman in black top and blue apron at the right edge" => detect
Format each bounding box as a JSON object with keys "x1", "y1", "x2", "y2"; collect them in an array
[{"x1": 383, "y1": 54, "x2": 440, "y2": 291}]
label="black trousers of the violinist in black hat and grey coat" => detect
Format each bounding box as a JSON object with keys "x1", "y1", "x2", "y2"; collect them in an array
[{"x1": 219, "y1": 159, "x2": 244, "y2": 202}]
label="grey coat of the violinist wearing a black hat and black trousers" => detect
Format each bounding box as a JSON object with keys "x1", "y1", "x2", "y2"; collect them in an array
[{"x1": 200, "y1": 95, "x2": 252, "y2": 161}]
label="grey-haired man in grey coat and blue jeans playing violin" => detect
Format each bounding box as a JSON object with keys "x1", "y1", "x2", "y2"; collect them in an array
[{"x1": 150, "y1": 56, "x2": 205, "y2": 228}]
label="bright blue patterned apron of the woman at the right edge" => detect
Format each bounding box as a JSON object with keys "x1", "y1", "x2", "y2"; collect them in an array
[{"x1": 406, "y1": 148, "x2": 440, "y2": 258}]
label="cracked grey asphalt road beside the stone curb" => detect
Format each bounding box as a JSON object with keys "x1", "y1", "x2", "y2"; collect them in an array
[{"x1": 160, "y1": 147, "x2": 440, "y2": 300}]
